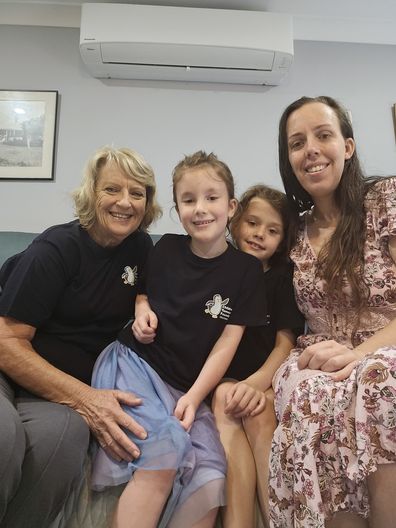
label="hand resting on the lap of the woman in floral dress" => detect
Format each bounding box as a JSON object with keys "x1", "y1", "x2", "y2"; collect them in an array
[{"x1": 297, "y1": 340, "x2": 364, "y2": 381}]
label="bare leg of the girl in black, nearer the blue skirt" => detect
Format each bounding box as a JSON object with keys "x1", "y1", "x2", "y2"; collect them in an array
[{"x1": 212, "y1": 382, "x2": 256, "y2": 528}]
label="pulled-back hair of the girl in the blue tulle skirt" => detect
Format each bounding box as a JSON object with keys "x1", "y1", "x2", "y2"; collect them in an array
[{"x1": 172, "y1": 150, "x2": 235, "y2": 210}]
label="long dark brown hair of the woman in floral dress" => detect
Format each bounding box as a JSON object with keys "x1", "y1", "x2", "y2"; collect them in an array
[{"x1": 278, "y1": 96, "x2": 379, "y2": 339}]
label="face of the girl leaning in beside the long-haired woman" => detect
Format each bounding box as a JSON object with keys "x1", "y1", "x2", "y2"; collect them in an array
[{"x1": 235, "y1": 197, "x2": 283, "y2": 270}]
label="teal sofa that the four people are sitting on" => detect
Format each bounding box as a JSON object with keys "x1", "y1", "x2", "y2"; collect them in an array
[{"x1": 0, "y1": 231, "x2": 263, "y2": 528}]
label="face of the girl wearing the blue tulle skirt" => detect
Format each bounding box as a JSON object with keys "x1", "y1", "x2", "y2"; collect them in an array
[{"x1": 176, "y1": 167, "x2": 236, "y2": 254}]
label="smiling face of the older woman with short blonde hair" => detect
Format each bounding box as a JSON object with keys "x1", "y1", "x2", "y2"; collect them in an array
[{"x1": 88, "y1": 163, "x2": 146, "y2": 247}]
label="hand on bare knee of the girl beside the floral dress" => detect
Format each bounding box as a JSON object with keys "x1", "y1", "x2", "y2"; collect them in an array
[{"x1": 224, "y1": 381, "x2": 265, "y2": 418}]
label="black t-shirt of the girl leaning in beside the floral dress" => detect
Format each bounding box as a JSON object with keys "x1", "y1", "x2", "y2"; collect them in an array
[{"x1": 225, "y1": 264, "x2": 304, "y2": 380}]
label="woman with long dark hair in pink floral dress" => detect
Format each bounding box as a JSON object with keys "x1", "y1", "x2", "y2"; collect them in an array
[{"x1": 270, "y1": 97, "x2": 396, "y2": 528}]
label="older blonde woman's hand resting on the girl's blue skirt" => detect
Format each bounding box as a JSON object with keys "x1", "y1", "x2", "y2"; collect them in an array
[{"x1": 73, "y1": 386, "x2": 147, "y2": 461}]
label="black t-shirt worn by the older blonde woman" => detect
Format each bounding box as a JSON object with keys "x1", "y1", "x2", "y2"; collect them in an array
[{"x1": 0, "y1": 221, "x2": 152, "y2": 383}]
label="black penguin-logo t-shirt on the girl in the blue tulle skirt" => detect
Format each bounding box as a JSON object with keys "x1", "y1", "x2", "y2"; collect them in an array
[{"x1": 119, "y1": 235, "x2": 267, "y2": 391}]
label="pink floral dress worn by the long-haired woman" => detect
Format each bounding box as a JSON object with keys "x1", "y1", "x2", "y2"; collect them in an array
[{"x1": 269, "y1": 178, "x2": 396, "y2": 528}]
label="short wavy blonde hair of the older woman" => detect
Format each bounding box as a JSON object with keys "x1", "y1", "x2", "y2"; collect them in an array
[{"x1": 72, "y1": 146, "x2": 162, "y2": 231}]
